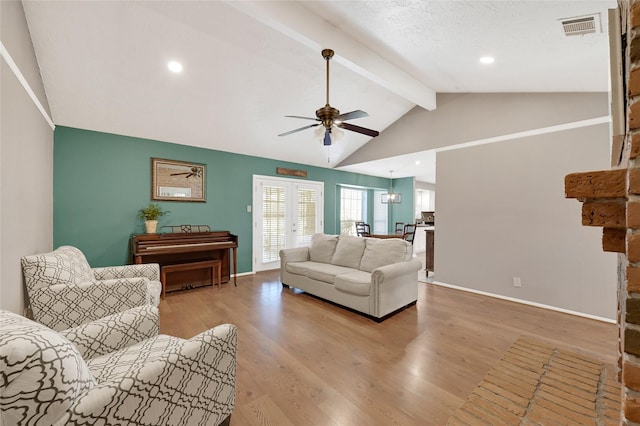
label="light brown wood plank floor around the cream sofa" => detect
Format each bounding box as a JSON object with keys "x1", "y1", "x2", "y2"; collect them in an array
[{"x1": 160, "y1": 271, "x2": 617, "y2": 426}]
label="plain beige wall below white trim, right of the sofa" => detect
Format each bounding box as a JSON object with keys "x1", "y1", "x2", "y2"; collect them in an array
[{"x1": 434, "y1": 124, "x2": 616, "y2": 319}]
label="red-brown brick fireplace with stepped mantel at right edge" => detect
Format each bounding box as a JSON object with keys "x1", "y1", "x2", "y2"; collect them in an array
[{"x1": 565, "y1": 0, "x2": 640, "y2": 425}]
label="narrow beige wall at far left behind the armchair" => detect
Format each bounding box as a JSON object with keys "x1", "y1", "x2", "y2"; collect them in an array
[{"x1": 0, "y1": 0, "x2": 53, "y2": 313}]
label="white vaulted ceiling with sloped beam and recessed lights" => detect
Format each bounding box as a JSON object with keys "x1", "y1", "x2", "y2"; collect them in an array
[{"x1": 24, "y1": 0, "x2": 616, "y2": 182}]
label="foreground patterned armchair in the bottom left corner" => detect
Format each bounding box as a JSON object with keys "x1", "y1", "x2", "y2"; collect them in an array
[{"x1": 0, "y1": 306, "x2": 237, "y2": 426}]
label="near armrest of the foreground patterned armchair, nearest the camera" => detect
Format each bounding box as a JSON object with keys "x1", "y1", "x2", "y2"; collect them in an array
[{"x1": 64, "y1": 324, "x2": 237, "y2": 425}]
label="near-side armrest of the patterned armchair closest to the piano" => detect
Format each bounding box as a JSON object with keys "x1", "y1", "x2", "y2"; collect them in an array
[{"x1": 31, "y1": 278, "x2": 149, "y2": 331}]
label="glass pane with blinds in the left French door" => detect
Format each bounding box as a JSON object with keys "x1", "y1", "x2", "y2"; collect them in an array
[{"x1": 262, "y1": 185, "x2": 286, "y2": 263}]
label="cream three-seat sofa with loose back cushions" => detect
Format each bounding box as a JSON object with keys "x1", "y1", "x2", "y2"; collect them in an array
[{"x1": 280, "y1": 234, "x2": 422, "y2": 321}]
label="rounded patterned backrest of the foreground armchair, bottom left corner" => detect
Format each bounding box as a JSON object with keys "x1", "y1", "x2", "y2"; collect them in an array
[{"x1": 0, "y1": 311, "x2": 96, "y2": 425}]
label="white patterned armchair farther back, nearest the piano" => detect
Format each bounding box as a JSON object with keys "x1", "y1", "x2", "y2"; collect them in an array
[{"x1": 21, "y1": 246, "x2": 162, "y2": 331}]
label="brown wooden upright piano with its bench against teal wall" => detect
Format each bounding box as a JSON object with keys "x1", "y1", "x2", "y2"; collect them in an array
[{"x1": 131, "y1": 231, "x2": 238, "y2": 291}]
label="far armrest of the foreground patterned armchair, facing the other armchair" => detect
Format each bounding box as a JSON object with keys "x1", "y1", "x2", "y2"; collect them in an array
[{"x1": 59, "y1": 305, "x2": 160, "y2": 360}]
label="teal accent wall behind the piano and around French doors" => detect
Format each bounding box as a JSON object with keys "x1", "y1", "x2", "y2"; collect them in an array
[{"x1": 53, "y1": 126, "x2": 413, "y2": 273}]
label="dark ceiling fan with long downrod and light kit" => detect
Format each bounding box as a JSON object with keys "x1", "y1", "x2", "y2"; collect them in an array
[{"x1": 278, "y1": 49, "x2": 380, "y2": 146}]
